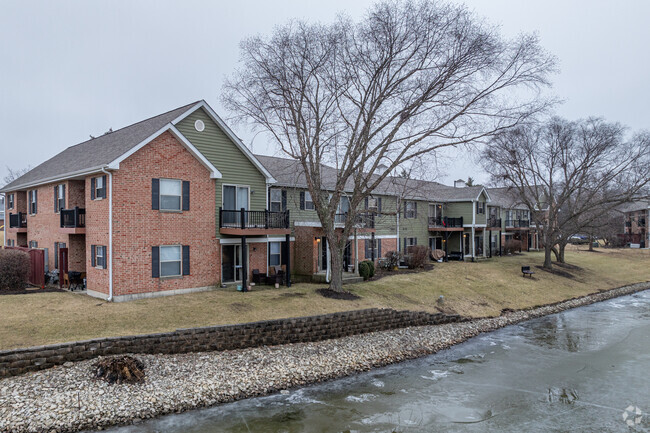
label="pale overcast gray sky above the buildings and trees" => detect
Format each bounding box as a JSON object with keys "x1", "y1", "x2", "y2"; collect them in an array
[{"x1": 0, "y1": 0, "x2": 650, "y2": 183}]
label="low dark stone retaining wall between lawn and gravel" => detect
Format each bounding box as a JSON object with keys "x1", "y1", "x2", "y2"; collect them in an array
[{"x1": 0, "y1": 308, "x2": 461, "y2": 377}]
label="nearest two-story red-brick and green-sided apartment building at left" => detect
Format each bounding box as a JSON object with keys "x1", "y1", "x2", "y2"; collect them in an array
[{"x1": 1, "y1": 101, "x2": 291, "y2": 300}]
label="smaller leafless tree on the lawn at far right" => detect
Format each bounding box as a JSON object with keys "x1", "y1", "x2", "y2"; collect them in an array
[{"x1": 484, "y1": 117, "x2": 650, "y2": 268}]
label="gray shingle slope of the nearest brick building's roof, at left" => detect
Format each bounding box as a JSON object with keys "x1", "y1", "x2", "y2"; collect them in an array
[{"x1": 0, "y1": 101, "x2": 200, "y2": 192}]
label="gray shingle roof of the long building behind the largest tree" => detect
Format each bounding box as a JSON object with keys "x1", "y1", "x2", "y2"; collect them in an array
[{"x1": 255, "y1": 155, "x2": 483, "y2": 202}]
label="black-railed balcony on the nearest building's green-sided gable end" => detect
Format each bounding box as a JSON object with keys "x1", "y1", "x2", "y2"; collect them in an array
[{"x1": 219, "y1": 208, "x2": 290, "y2": 236}]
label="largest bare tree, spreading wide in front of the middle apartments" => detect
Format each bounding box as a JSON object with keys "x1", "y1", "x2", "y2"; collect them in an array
[{"x1": 223, "y1": 0, "x2": 555, "y2": 290}]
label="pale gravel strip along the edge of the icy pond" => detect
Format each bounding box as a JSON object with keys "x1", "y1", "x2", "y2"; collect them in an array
[{"x1": 0, "y1": 283, "x2": 650, "y2": 432}]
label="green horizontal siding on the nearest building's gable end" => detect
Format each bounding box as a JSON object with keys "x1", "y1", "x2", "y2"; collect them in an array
[{"x1": 176, "y1": 109, "x2": 266, "y2": 237}]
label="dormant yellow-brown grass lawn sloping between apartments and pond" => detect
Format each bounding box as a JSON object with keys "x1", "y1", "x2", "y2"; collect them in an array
[{"x1": 0, "y1": 247, "x2": 650, "y2": 349}]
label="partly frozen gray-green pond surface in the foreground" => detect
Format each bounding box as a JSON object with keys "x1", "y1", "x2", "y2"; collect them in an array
[{"x1": 106, "y1": 291, "x2": 650, "y2": 433}]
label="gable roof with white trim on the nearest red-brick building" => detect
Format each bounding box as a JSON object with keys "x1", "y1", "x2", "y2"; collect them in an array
[{"x1": 0, "y1": 100, "x2": 275, "y2": 192}]
